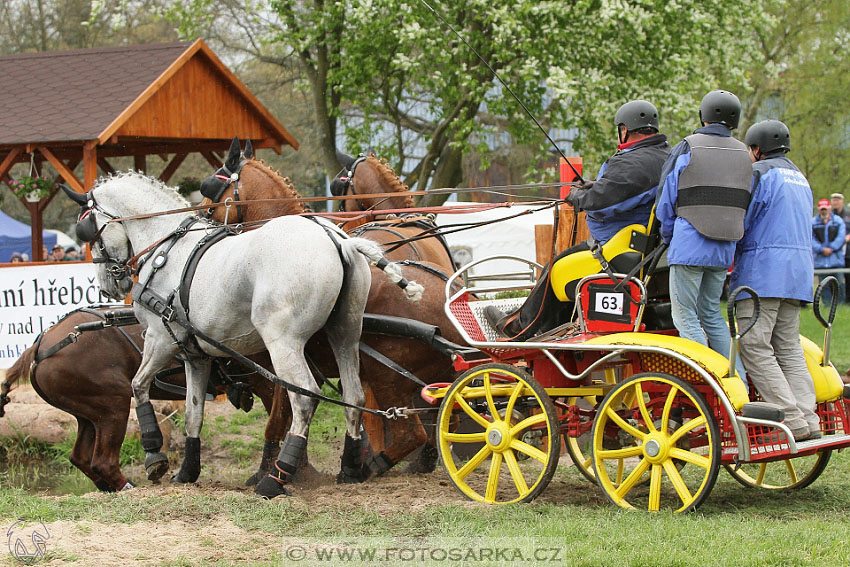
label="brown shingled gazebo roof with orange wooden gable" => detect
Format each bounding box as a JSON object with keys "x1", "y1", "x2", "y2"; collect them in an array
[{"x1": 0, "y1": 40, "x2": 298, "y2": 151}]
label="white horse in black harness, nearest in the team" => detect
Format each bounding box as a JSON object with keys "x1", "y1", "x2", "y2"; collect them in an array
[{"x1": 66, "y1": 173, "x2": 422, "y2": 497}]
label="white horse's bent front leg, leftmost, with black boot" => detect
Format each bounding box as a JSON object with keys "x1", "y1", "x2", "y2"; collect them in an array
[{"x1": 132, "y1": 336, "x2": 177, "y2": 482}]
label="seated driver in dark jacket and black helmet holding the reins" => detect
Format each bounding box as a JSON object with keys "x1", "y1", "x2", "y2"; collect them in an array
[{"x1": 485, "y1": 100, "x2": 670, "y2": 340}]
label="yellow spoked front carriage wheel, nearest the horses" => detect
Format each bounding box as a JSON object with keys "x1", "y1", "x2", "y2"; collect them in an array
[{"x1": 437, "y1": 363, "x2": 560, "y2": 504}]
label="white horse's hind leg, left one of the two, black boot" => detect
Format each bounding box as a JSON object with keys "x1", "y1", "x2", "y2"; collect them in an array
[{"x1": 254, "y1": 340, "x2": 319, "y2": 499}]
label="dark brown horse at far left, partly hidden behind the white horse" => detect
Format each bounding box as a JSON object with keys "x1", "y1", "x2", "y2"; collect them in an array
[{"x1": 0, "y1": 306, "x2": 278, "y2": 492}]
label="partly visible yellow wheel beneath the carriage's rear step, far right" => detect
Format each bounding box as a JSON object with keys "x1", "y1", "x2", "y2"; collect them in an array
[{"x1": 724, "y1": 450, "x2": 832, "y2": 490}]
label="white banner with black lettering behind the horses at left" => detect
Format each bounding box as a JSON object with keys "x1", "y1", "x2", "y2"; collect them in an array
[{"x1": 0, "y1": 263, "x2": 108, "y2": 368}]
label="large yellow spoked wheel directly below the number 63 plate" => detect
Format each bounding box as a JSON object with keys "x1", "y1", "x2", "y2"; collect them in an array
[{"x1": 592, "y1": 373, "x2": 720, "y2": 512}]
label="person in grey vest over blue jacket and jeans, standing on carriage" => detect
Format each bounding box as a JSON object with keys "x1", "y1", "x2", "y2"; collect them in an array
[{"x1": 655, "y1": 90, "x2": 753, "y2": 379}]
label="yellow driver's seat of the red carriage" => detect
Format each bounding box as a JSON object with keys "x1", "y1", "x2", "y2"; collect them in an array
[{"x1": 550, "y1": 224, "x2": 653, "y2": 302}]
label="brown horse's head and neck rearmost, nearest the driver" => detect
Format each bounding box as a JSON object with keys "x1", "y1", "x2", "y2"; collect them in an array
[{"x1": 331, "y1": 152, "x2": 413, "y2": 211}]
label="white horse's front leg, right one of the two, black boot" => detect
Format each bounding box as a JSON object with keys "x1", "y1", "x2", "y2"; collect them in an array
[{"x1": 171, "y1": 357, "x2": 212, "y2": 483}]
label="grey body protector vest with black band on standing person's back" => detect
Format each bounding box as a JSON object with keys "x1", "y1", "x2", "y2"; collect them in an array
[{"x1": 676, "y1": 134, "x2": 753, "y2": 242}]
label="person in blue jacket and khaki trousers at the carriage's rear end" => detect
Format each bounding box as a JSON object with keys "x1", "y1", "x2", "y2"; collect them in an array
[{"x1": 730, "y1": 120, "x2": 820, "y2": 441}]
